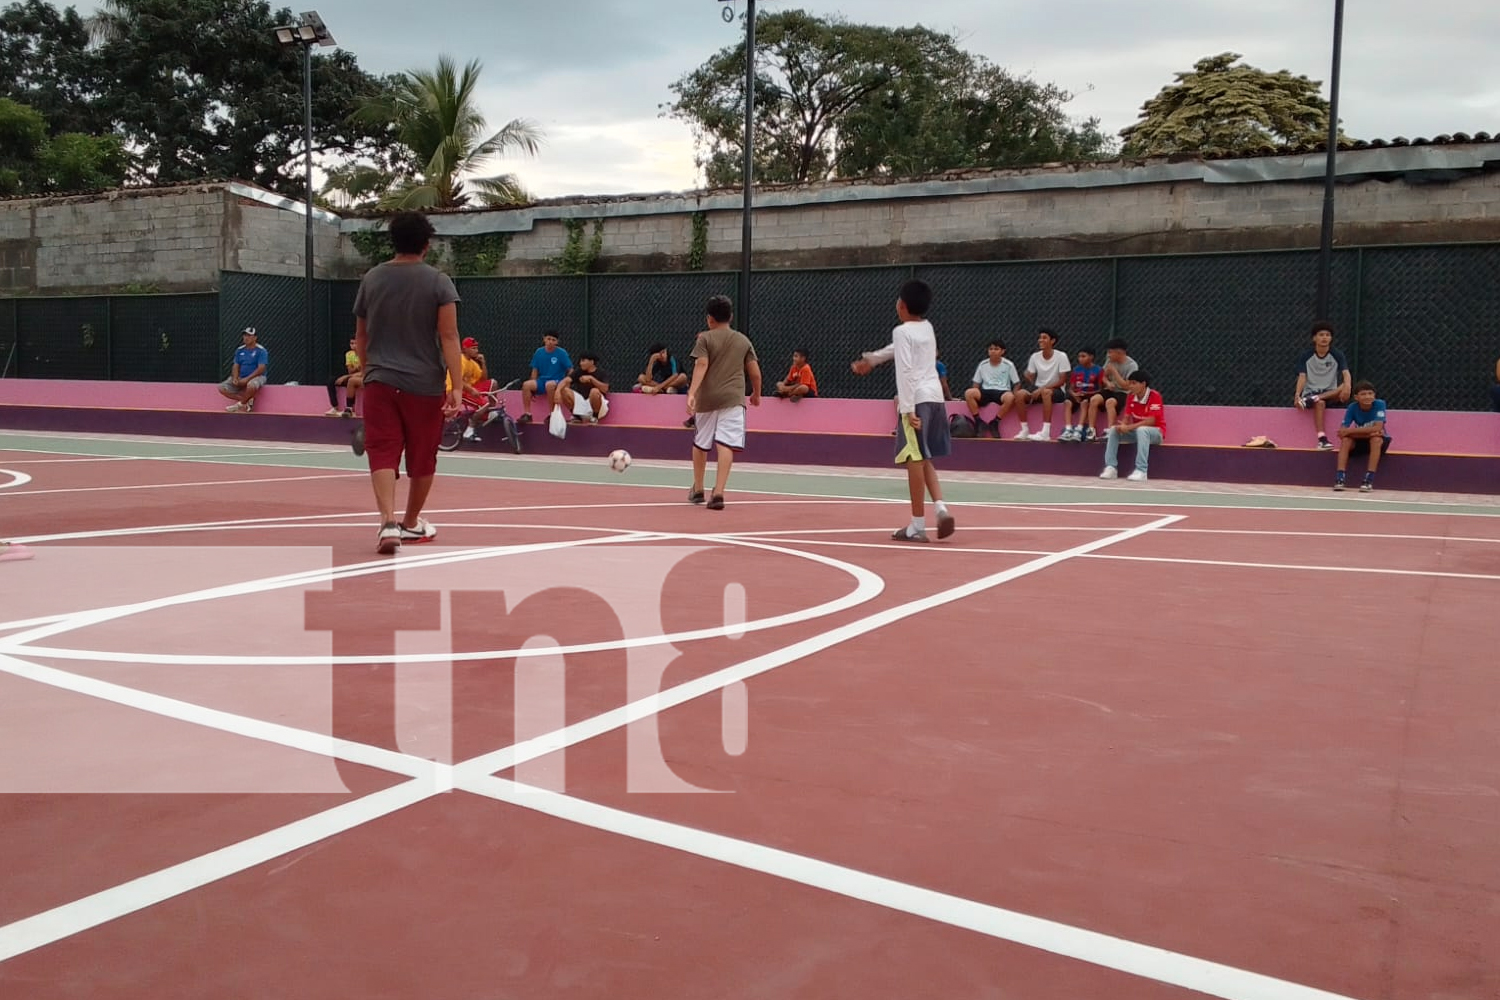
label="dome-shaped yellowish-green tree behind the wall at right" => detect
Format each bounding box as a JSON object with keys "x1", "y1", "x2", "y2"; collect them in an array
[{"x1": 1121, "y1": 52, "x2": 1329, "y2": 156}]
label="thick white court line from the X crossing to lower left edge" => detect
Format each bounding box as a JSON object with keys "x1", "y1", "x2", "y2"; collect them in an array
[{"x1": 0, "y1": 781, "x2": 438, "y2": 963}]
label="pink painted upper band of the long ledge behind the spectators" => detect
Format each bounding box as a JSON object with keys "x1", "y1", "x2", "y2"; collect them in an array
[{"x1": 0, "y1": 379, "x2": 1500, "y2": 456}]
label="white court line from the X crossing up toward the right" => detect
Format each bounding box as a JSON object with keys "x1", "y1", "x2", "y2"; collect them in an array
[{"x1": 459, "y1": 514, "x2": 1182, "y2": 774}]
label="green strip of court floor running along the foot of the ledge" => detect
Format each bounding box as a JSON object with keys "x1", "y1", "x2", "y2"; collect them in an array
[{"x1": 0, "y1": 433, "x2": 1500, "y2": 517}]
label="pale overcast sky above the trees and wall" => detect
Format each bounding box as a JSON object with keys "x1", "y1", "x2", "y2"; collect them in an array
[{"x1": 78, "y1": 0, "x2": 1500, "y2": 198}]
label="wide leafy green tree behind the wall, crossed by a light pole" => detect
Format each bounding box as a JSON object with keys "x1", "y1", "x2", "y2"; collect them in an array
[{"x1": 663, "y1": 10, "x2": 1110, "y2": 186}]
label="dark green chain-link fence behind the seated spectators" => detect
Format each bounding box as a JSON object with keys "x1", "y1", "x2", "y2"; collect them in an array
[{"x1": 0, "y1": 243, "x2": 1500, "y2": 409}]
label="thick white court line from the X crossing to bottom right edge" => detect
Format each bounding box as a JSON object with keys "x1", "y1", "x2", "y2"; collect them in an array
[{"x1": 461, "y1": 777, "x2": 1374, "y2": 1000}]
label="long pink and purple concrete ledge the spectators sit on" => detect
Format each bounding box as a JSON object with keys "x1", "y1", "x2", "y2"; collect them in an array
[{"x1": 0, "y1": 379, "x2": 1500, "y2": 493}]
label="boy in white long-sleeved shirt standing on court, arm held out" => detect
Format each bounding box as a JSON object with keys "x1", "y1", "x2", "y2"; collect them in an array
[{"x1": 851, "y1": 280, "x2": 954, "y2": 541}]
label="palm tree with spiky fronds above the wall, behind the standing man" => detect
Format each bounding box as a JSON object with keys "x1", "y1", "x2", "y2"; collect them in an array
[{"x1": 359, "y1": 55, "x2": 543, "y2": 208}]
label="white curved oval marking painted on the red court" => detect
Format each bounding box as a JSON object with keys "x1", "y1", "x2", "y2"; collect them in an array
[{"x1": 0, "y1": 525, "x2": 885, "y2": 666}]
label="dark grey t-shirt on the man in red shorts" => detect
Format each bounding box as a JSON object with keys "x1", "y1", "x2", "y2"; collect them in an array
[{"x1": 354, "y1": 261, "x2": 459, "y2": 396}]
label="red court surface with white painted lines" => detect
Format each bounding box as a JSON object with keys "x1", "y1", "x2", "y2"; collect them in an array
[{"x1": 0, "y1": 451, "x2": 1500, "y2": 1000}]
